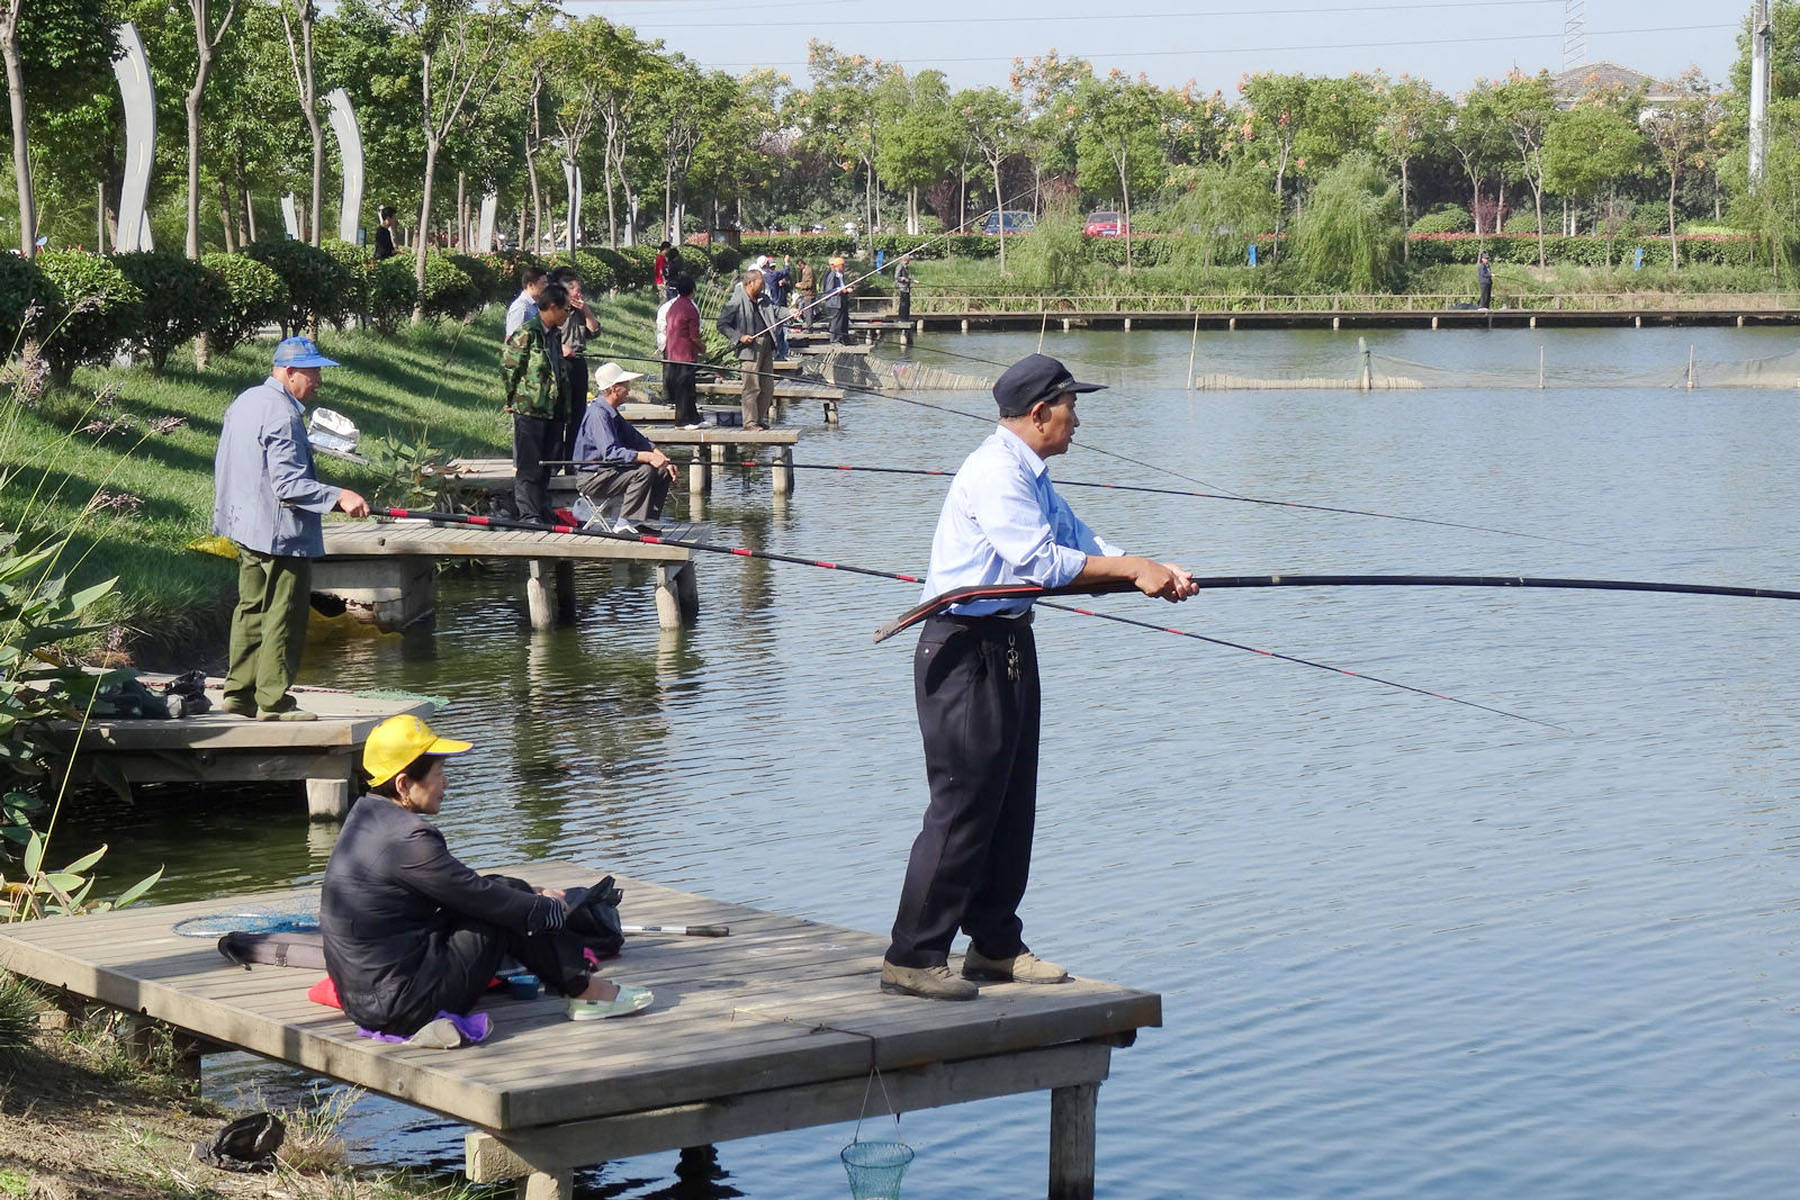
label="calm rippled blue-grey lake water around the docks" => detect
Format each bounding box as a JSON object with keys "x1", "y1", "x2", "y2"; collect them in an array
[{"x1": 65, "y1": 329, "x2": 1800, "y2": 1200}]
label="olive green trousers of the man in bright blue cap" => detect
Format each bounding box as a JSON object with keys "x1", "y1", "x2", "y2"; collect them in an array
[{"x1": 225, "y1": 545, "x2": 313, "y2": 712}]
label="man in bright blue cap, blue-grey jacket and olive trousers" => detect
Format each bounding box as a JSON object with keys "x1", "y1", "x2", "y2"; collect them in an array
[{"x1": 212, "y1": 338, "x2": 369, "y2": 721}]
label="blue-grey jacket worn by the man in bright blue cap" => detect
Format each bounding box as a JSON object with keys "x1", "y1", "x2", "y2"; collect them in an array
[{"x1": 212, "y1": 376, "x2": 340, "y2": 558}]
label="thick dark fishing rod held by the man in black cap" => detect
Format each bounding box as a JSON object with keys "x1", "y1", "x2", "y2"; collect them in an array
[{"x1": 875, "y1": 576, "x2": 1800, "y2": 642}]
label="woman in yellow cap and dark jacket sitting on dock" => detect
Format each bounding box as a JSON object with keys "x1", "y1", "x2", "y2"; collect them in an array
[{"x1": 319, "y1": 716, "x2": 652, "y2": 1036}]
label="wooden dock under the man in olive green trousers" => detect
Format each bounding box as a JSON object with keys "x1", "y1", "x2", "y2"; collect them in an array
[{"x1": 47, "y1": 671, "x2": 434, "y2": 820}]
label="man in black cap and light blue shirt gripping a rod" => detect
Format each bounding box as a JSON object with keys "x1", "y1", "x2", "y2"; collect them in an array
[{"x1": 882, "y1": 354, "x2": 1199, "y2": 1000}]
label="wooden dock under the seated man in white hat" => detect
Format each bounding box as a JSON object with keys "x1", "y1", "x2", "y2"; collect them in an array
[{"x1": 313, "y1": 525, "x2": 700, "y2": 630}]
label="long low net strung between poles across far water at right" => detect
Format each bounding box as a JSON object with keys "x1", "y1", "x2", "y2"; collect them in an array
[{"x1": 1193, "y1": 341, "x2": 1800, "y2": 392}]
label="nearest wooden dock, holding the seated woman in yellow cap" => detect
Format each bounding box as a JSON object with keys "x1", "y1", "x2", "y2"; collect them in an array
[{"x1": 0, "y1": 864, "x2": 1161, "y2": 1200}]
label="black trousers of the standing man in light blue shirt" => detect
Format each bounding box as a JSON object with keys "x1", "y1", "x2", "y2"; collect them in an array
[{"x1": 887, "y1": 617, "x2": 1040, "y2": 966}]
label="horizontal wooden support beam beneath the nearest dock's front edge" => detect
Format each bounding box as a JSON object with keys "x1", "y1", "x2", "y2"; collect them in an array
[{"x1": 464, "y1": 1043, "x2": 1111, "y2": 1184}]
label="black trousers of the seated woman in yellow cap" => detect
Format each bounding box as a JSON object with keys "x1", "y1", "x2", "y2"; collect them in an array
[{"x1": 382, "y1": 882, "x2": 592, "y2": 1036}]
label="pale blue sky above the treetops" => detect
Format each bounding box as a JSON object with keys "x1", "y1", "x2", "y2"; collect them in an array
[{"x1": 562, "y1": 0, "x2": 1750, "y2": 97}]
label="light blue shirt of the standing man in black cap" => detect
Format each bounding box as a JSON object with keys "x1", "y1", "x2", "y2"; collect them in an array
[{"x1": 922, "y1": 425, "x2": 1125, "y2": 617}]
